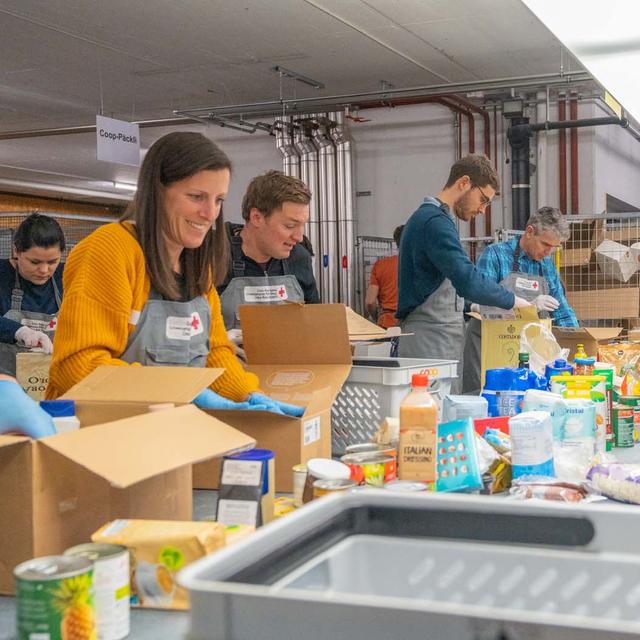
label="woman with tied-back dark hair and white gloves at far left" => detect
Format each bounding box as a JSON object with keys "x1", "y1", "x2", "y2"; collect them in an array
[{"x1": 0, "y1": 213, "x2": 65, "y2": 375}]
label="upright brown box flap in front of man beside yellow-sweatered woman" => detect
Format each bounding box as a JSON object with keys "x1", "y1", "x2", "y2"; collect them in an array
[{"x1": 239, "y1": 304, "x2": 351, "y2": 365}]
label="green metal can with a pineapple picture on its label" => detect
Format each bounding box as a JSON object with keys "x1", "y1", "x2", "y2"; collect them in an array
[{"x1": 13, "y1": 556, "x2": 97, "y2": 640}]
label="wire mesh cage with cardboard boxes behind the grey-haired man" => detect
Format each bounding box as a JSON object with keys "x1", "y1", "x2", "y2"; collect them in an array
[{"x1": 557, "y1": 213, "x2": 640, "y2": 329}]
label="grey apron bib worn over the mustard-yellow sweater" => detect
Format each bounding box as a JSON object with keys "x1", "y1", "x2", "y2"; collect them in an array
[{"x1": 120, "y1": 287, "x2": 211, "y2": 367}]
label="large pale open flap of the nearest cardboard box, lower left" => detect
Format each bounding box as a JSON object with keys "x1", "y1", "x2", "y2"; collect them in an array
[{"x1": 36, "y1": 404, "x2": 256, "y2": 489}]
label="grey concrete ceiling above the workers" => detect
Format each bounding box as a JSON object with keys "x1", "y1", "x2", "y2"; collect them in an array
[{"x1": 0, "y1": 0, "x2": 580, "y2": 202}]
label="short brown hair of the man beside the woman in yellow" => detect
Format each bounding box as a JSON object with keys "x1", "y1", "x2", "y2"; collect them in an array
[{"x1": 242, "y1": 171, "x2": 311, "y2": 220}]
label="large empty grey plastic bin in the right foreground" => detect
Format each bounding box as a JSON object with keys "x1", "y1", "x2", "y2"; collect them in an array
[{"x1": 179, "y1": 490, "x2": 640, "y2": 640}]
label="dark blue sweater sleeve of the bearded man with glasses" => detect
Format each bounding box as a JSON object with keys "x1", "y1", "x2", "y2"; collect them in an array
[{"x1": 424, "y1": 216, "x2": 515, "y2": 309}]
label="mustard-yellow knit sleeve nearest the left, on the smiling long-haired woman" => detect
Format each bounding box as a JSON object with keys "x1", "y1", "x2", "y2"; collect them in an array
[{"x1": 46, "y1": 225, "x2": 149, "y2": 399}]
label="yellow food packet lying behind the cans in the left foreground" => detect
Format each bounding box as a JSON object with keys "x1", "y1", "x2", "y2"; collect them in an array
[{"x1": 91, "y1": 519, "x2": 225, "y2": 609}]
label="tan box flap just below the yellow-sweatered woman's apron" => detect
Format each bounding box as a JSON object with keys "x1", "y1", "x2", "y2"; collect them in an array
[{"x1": 62, "y1": 365, "x2": 224, "y2": 404}]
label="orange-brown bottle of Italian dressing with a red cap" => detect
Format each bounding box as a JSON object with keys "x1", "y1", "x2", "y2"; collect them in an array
[{"x1": 398, "y1": 373, "x2": 438, "y2": 482}]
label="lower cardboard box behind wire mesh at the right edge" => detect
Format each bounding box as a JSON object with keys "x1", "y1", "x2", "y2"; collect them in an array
[{"x1": 567, "y1": 287, "x2": 640, "y2": 320}]
